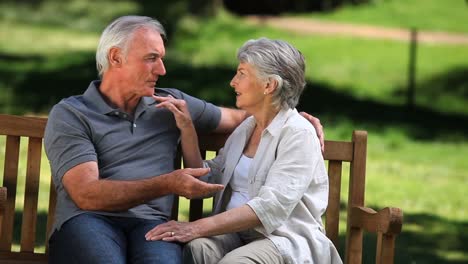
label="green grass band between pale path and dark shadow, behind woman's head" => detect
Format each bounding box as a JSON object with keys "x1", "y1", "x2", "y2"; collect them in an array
[{"x1": 170, "y1": 12, "x2": 468, "y2": 116}]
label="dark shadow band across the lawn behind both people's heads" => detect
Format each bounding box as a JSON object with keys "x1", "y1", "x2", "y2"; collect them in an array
[{"x1": 0, "y1": 52, "x2": 468, "y2": 141}]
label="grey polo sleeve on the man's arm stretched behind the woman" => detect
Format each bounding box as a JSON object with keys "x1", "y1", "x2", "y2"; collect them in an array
[{"x1": 166, "y1": 89, "x2": 221, "y2": 132}]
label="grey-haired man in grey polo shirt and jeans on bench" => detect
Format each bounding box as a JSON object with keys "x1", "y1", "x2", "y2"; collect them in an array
[{"x1": 45, "y1": 16, "x2": 323, "y2": 263}]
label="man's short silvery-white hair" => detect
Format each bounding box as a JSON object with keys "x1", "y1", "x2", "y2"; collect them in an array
[{"x1": 96, "y1": 16, "x2": 166, "y2": 77}]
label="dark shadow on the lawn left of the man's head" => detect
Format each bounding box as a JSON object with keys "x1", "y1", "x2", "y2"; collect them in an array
[{"x1": 0, "y1": 52, "x2": 97, "y2": 114}]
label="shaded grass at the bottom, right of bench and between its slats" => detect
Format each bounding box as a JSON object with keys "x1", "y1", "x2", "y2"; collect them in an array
[{"x1": 13, "y1": 206, "x2": 468, "y2": 264}]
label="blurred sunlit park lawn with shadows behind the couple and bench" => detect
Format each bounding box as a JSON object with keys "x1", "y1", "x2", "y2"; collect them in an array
[{"x1": 0, "y1": 0, "x2": 468, "y2": 263}]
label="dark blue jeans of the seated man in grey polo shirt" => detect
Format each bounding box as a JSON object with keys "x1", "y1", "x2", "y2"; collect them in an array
[{"x1": 49, "y1": 213, "x2": 182, "y2": 264}]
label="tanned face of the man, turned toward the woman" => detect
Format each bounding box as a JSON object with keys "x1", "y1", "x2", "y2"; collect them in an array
[{"x1": 120, "y1": 28, "x2": 166, "y2": 97}]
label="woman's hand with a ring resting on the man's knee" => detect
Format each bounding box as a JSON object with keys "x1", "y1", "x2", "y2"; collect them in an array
[{"x1": 145, "y1": 221, "x2": 200, "y2": 243}]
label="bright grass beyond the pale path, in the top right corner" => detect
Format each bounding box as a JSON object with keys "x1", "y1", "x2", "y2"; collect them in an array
[{"x1": 294, "y1": 0, "x2": 468, "y2": 34}]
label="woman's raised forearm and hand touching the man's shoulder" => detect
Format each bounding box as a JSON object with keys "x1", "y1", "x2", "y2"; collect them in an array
[{"x1": 153, "y1": 96, "x2": 203, "y2": 168}]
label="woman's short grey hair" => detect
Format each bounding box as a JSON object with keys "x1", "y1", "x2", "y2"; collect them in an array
[{"x1": 237, "y1": 38, "x2": 306, "y2": 109}]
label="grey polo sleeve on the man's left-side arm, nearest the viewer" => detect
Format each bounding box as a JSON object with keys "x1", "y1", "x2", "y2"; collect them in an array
[{"x1": 44, "y1": 103, "x2": 97, "y2": 186}]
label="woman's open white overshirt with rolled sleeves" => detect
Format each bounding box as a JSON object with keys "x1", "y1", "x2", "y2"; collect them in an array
[{"x1": 205, "y1": 109, "x2": 342, "y2": 264}]
